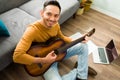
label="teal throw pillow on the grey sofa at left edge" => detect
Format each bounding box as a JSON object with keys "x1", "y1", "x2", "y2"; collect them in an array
[{"x1": 0, "y1": 20, "x2": 10, "y2": 37}]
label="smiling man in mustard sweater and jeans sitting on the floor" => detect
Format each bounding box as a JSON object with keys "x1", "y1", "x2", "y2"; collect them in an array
[{"x1": 13, "y1": 0, "x2": 96, "y2": 80}]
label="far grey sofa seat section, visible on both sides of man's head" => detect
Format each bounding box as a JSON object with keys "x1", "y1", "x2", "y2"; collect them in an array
[{"x1": 19, "y1": 0, "x2": 80, "y2": 24}]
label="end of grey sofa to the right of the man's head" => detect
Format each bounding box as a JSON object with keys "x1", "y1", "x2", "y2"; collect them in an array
[{"x1": 58, "y1": 0, "x2": 80, "y2": 24}]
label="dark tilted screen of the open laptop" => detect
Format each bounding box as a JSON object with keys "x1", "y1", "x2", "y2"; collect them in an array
[{"x1": 106, "y1": 40, "x2": 118, "y2": 62}]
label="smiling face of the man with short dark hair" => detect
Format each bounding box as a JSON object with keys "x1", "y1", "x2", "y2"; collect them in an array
[{"x1": 41, "y1": 5, "x2": 60, "y2": 28}]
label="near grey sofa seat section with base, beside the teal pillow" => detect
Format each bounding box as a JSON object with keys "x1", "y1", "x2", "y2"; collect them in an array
[{"x1": 0, "y1": 8, "x2": 37, "y2": 70}]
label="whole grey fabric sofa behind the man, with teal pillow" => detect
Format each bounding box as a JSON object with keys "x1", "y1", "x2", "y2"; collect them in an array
[{"x1": 0, "y1": 0, "x2": 80, "y2": 71}]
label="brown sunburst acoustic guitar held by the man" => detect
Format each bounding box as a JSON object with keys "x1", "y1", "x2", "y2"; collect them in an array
[{"x1": 24, "y1": 28, "x2": 95, "y2": 76}]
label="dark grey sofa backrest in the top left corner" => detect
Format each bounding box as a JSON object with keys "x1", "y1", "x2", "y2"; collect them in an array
[{"x1": 0, "y1": 0, "x2": 29, "y2": 14}]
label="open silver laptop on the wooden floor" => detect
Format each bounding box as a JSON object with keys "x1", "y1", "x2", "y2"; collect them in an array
[{"x1": 93, "y1": 40, "x2": 118, "y2": 64}]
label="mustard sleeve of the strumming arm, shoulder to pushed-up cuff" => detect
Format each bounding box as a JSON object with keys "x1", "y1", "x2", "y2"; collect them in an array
[{"x1": 13, "y1": 27, "x2": 35, "y2": 64}]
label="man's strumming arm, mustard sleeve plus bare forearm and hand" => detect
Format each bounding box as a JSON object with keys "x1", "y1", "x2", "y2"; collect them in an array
[{"x1": 13, "y1": 25, "x2": 56, "y2": 65}]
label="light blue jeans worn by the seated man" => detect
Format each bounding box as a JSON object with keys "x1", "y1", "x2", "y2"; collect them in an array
[{"x1": 43, "y1": 43, "x2": 88, "y2": 80}]
